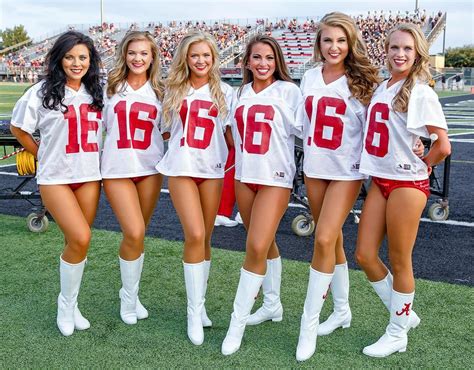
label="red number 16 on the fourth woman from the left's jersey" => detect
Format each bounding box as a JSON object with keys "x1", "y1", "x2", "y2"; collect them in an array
[{"x1": 234, "y1": 104, "x2": 275, "y2": 154}]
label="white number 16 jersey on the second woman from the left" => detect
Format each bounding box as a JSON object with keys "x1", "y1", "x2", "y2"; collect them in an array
[{"x1": 101, "y1": 81, "x2": 164, "y2": 179}]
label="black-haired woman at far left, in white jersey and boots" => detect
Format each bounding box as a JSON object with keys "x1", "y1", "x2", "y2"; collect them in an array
[{"x1": 11, "y1": 31, "x2": 103, "y2": 336}]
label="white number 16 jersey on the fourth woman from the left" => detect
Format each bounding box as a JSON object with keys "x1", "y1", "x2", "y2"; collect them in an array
[{"x1": 233, "y1": 81, "x2": 303, "y2": 188}]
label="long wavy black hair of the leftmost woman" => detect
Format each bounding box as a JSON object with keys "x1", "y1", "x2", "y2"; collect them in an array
[{"x1": 41, "y1": 31, "x2": 104, "y2": 112}]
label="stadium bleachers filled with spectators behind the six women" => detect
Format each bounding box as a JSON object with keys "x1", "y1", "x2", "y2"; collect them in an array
[{"x1": 0, "y1": 10, "x2": 446, "y2": 82}]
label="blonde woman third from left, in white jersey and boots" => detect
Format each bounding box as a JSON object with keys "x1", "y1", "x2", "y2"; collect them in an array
[{"x1": 157, "y1": 32, "x2": 235, "y2": 345}]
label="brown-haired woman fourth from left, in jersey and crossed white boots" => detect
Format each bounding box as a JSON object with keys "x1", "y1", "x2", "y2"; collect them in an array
[{"x1": 222, "y1": 35, "x2": 302, "y2": 355}]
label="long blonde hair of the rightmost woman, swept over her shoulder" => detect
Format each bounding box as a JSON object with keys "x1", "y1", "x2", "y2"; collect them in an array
[{"x1": 385, "y1": 23, "x2": 431, "y2": 112}]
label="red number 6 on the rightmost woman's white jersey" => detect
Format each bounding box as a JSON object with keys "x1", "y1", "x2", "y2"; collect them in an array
[{"x1": 365, "y1": 103, "x2": 390, "y2": 157}]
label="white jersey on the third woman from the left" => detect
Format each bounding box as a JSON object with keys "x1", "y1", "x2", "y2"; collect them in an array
[{"x1": 156, "y1": 82, "x2": 235, "y2": 179}]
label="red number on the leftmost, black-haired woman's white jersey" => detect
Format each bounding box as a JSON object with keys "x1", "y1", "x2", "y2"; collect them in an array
[{"x1": 64, "y1": 103, "x2": 102, "y2": 154}]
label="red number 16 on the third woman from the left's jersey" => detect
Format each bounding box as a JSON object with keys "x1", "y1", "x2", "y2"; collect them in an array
[{"x1": 179, "y1": 99, "x2": 218, "y2": 149}]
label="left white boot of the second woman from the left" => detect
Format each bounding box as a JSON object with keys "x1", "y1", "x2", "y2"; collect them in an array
[{"x1": 119, "y1": 256, "x2": 143, "y2": 325}]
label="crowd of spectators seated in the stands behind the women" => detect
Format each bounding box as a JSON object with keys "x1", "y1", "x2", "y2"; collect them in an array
[{"x1": 0, "y1": 10, "x2": 443, "y2": 81}]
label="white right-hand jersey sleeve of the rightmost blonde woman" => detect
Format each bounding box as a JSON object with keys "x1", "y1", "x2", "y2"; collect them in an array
[{"x1": 407, "y1": 84, "x2": 448, "y2": 137}]
